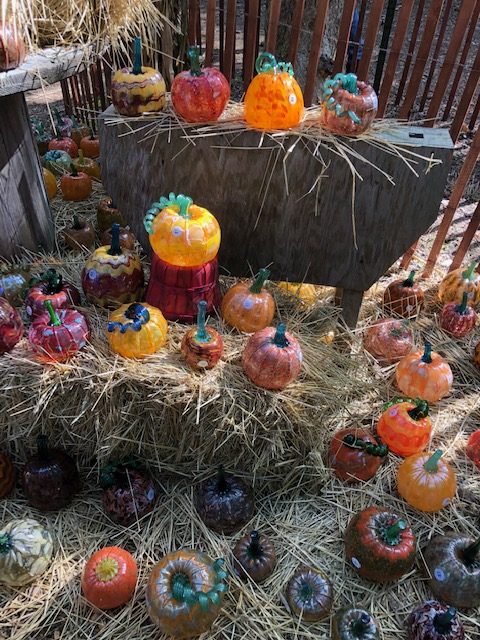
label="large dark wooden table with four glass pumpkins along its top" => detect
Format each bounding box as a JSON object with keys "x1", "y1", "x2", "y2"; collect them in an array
[{"x1": 99, "y1": 107, "x2": 453, "y2": 326}]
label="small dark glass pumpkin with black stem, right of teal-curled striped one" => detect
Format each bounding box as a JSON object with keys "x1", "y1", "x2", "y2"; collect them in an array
[{"x1": 233, "y1": 531, "x2": 277, "y2": 583}]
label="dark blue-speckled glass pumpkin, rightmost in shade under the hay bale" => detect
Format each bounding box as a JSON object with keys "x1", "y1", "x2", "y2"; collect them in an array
[{"x1": 194, "y1": 467, "x2": 255, "y2": 535}]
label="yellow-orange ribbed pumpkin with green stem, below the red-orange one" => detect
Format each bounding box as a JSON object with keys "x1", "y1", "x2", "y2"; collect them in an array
[{"x1": 397, "y1": 449, "x2": 457, "y2": 513}]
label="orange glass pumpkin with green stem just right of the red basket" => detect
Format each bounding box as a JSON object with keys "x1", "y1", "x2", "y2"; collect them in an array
[{"x1": 221, "y1": 269, "x2": 275, "y2": 333}]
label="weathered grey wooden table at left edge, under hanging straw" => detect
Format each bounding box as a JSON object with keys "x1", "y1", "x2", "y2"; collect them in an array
[{"x1": 0, "y1": 48, "x2": 85, "y2": 258}]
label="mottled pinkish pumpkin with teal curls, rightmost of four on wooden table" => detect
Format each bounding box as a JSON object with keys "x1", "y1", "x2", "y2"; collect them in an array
[{"x1": 320, "y1": 73, "x2": 378, "y2": 136}]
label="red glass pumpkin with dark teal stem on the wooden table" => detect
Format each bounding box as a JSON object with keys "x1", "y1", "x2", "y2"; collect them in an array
[{"x1": 171, "y1": 47, "x2": 230, "y2": 122}]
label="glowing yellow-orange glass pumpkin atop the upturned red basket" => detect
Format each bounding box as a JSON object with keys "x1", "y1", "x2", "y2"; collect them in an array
[{"x1": 143, "y1": 193, "x2": 220, "y2": 267}]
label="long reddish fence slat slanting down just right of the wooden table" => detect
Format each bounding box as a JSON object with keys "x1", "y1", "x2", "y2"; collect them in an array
[{"x1": 422, "y1": 127, "x2": 480, "y2": 278}]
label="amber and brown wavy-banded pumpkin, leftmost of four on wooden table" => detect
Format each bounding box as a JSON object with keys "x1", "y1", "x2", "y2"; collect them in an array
[{"x1": 111, "y1": 37, "x2": 166, "y2": 116}]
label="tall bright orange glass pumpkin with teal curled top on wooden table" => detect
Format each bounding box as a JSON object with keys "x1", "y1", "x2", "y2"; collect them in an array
[{"x1": 245, "y1": 52, "x2": 303, "y2": 129}]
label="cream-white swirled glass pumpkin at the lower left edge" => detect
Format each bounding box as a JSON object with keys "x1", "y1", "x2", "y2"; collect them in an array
[{"x1": 0, "y1": 518, "x2": 53, "y2": 587}]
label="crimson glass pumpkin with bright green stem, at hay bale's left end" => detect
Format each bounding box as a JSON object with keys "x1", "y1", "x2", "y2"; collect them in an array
[{"x1": 28, "y1": 300, "x2": 90, "y2": 362}]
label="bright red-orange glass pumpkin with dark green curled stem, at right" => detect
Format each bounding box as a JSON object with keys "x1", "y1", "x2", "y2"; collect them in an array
[{"x1": 377, "y1": 398, "x2": 432, "y2": 458}]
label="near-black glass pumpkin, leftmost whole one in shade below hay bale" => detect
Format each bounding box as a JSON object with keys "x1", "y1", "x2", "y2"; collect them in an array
[{"x1": 22, "y1": 434, "x2": 80, "y2": 511}]
